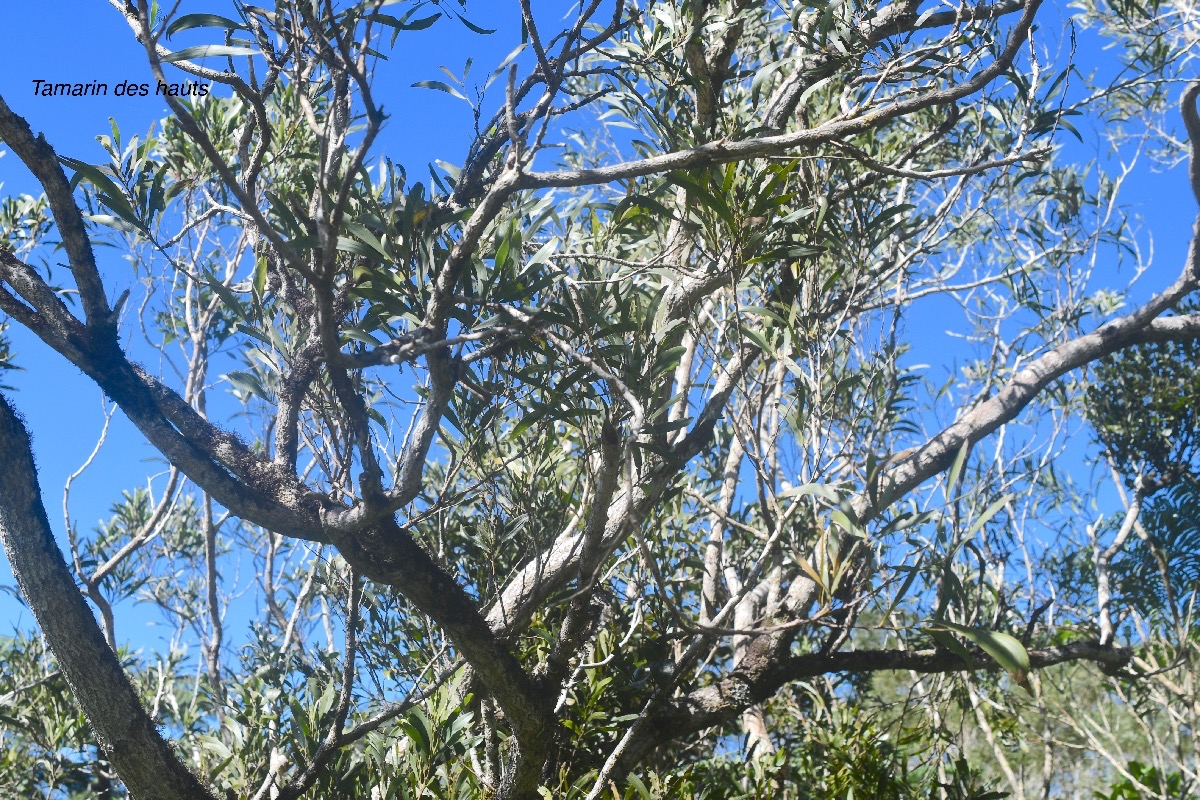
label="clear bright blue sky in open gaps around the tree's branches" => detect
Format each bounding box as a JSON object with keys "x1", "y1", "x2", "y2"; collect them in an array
[{"x1": 0, "y1": 0, "x2": 1195, "y2": 647}]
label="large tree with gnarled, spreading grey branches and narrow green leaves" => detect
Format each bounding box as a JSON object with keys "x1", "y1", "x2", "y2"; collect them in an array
[{"x1": 0, "y1": 0, "x2": 1200, "y2": 799}]
